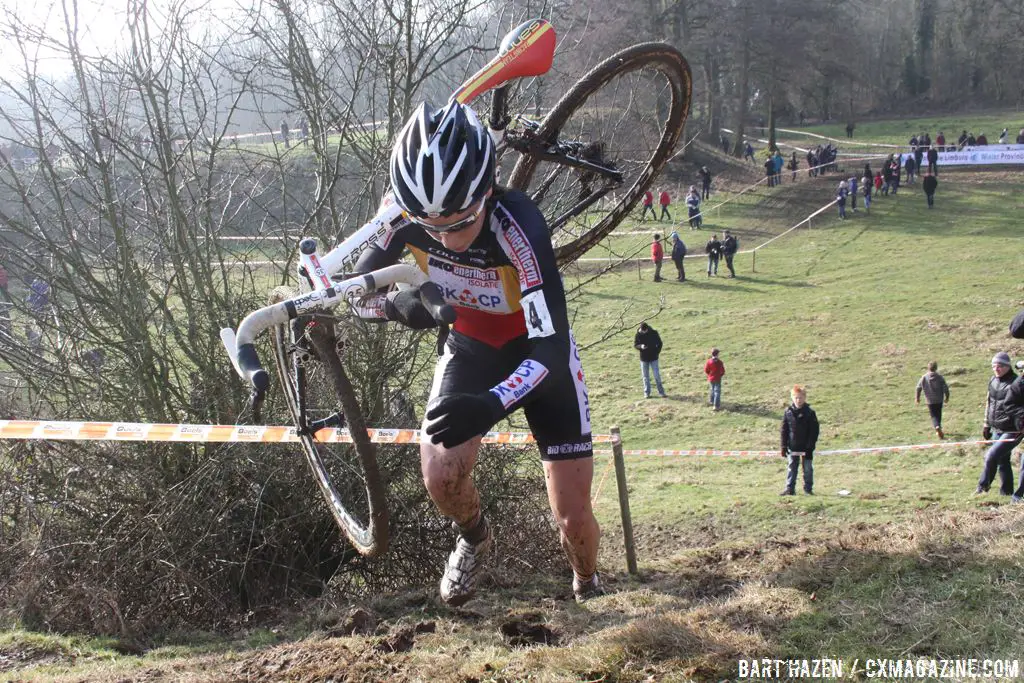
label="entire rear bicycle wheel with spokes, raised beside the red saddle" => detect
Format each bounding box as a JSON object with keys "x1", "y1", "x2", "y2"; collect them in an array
[{"x1": 508, "y1": 43, "x2": 691, "y2": 265}]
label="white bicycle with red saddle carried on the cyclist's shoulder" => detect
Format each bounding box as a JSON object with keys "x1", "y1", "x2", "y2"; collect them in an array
[{"x1": 220, "y1": 19, "x2": 690, "y2": 557}]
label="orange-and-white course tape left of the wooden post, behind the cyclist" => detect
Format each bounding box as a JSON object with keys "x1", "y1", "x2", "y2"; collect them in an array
[{"x1": 0, "y1": 420, "x2": 616, "y2": 444}]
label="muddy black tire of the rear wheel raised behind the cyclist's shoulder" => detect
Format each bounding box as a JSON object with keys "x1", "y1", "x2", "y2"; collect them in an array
[{"x1": 508, "y1": 43, "x2": 692, "y2": 267}]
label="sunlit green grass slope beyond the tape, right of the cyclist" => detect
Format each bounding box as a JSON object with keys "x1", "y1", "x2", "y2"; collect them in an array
[{"x1": 574, "y1": 176, "x2": 1024, "y2": 449}]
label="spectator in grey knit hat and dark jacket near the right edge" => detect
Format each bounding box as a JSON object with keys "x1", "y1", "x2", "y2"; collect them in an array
[{"x1": 975, "y1": 351, "x2": 1020, "y2": 496}]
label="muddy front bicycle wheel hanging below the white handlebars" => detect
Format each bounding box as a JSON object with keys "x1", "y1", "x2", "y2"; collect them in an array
[{"x1": 269, "y1": 287, "x2": 390, "y2": 557}]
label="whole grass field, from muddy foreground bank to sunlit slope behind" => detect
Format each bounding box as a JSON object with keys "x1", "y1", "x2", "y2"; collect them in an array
[{"x1": 0, "y1": 167, "x2": 1024, "y2": 681}]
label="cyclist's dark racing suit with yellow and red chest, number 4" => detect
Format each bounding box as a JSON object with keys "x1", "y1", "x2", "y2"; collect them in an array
[{"x1": 356, "y1": 189, "x2": 592, "y2": 459}]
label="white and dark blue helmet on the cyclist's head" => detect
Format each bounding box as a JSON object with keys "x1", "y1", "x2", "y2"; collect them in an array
[{"x1": 391, "y1": 101, "x2": 495, "y2": 218}]
